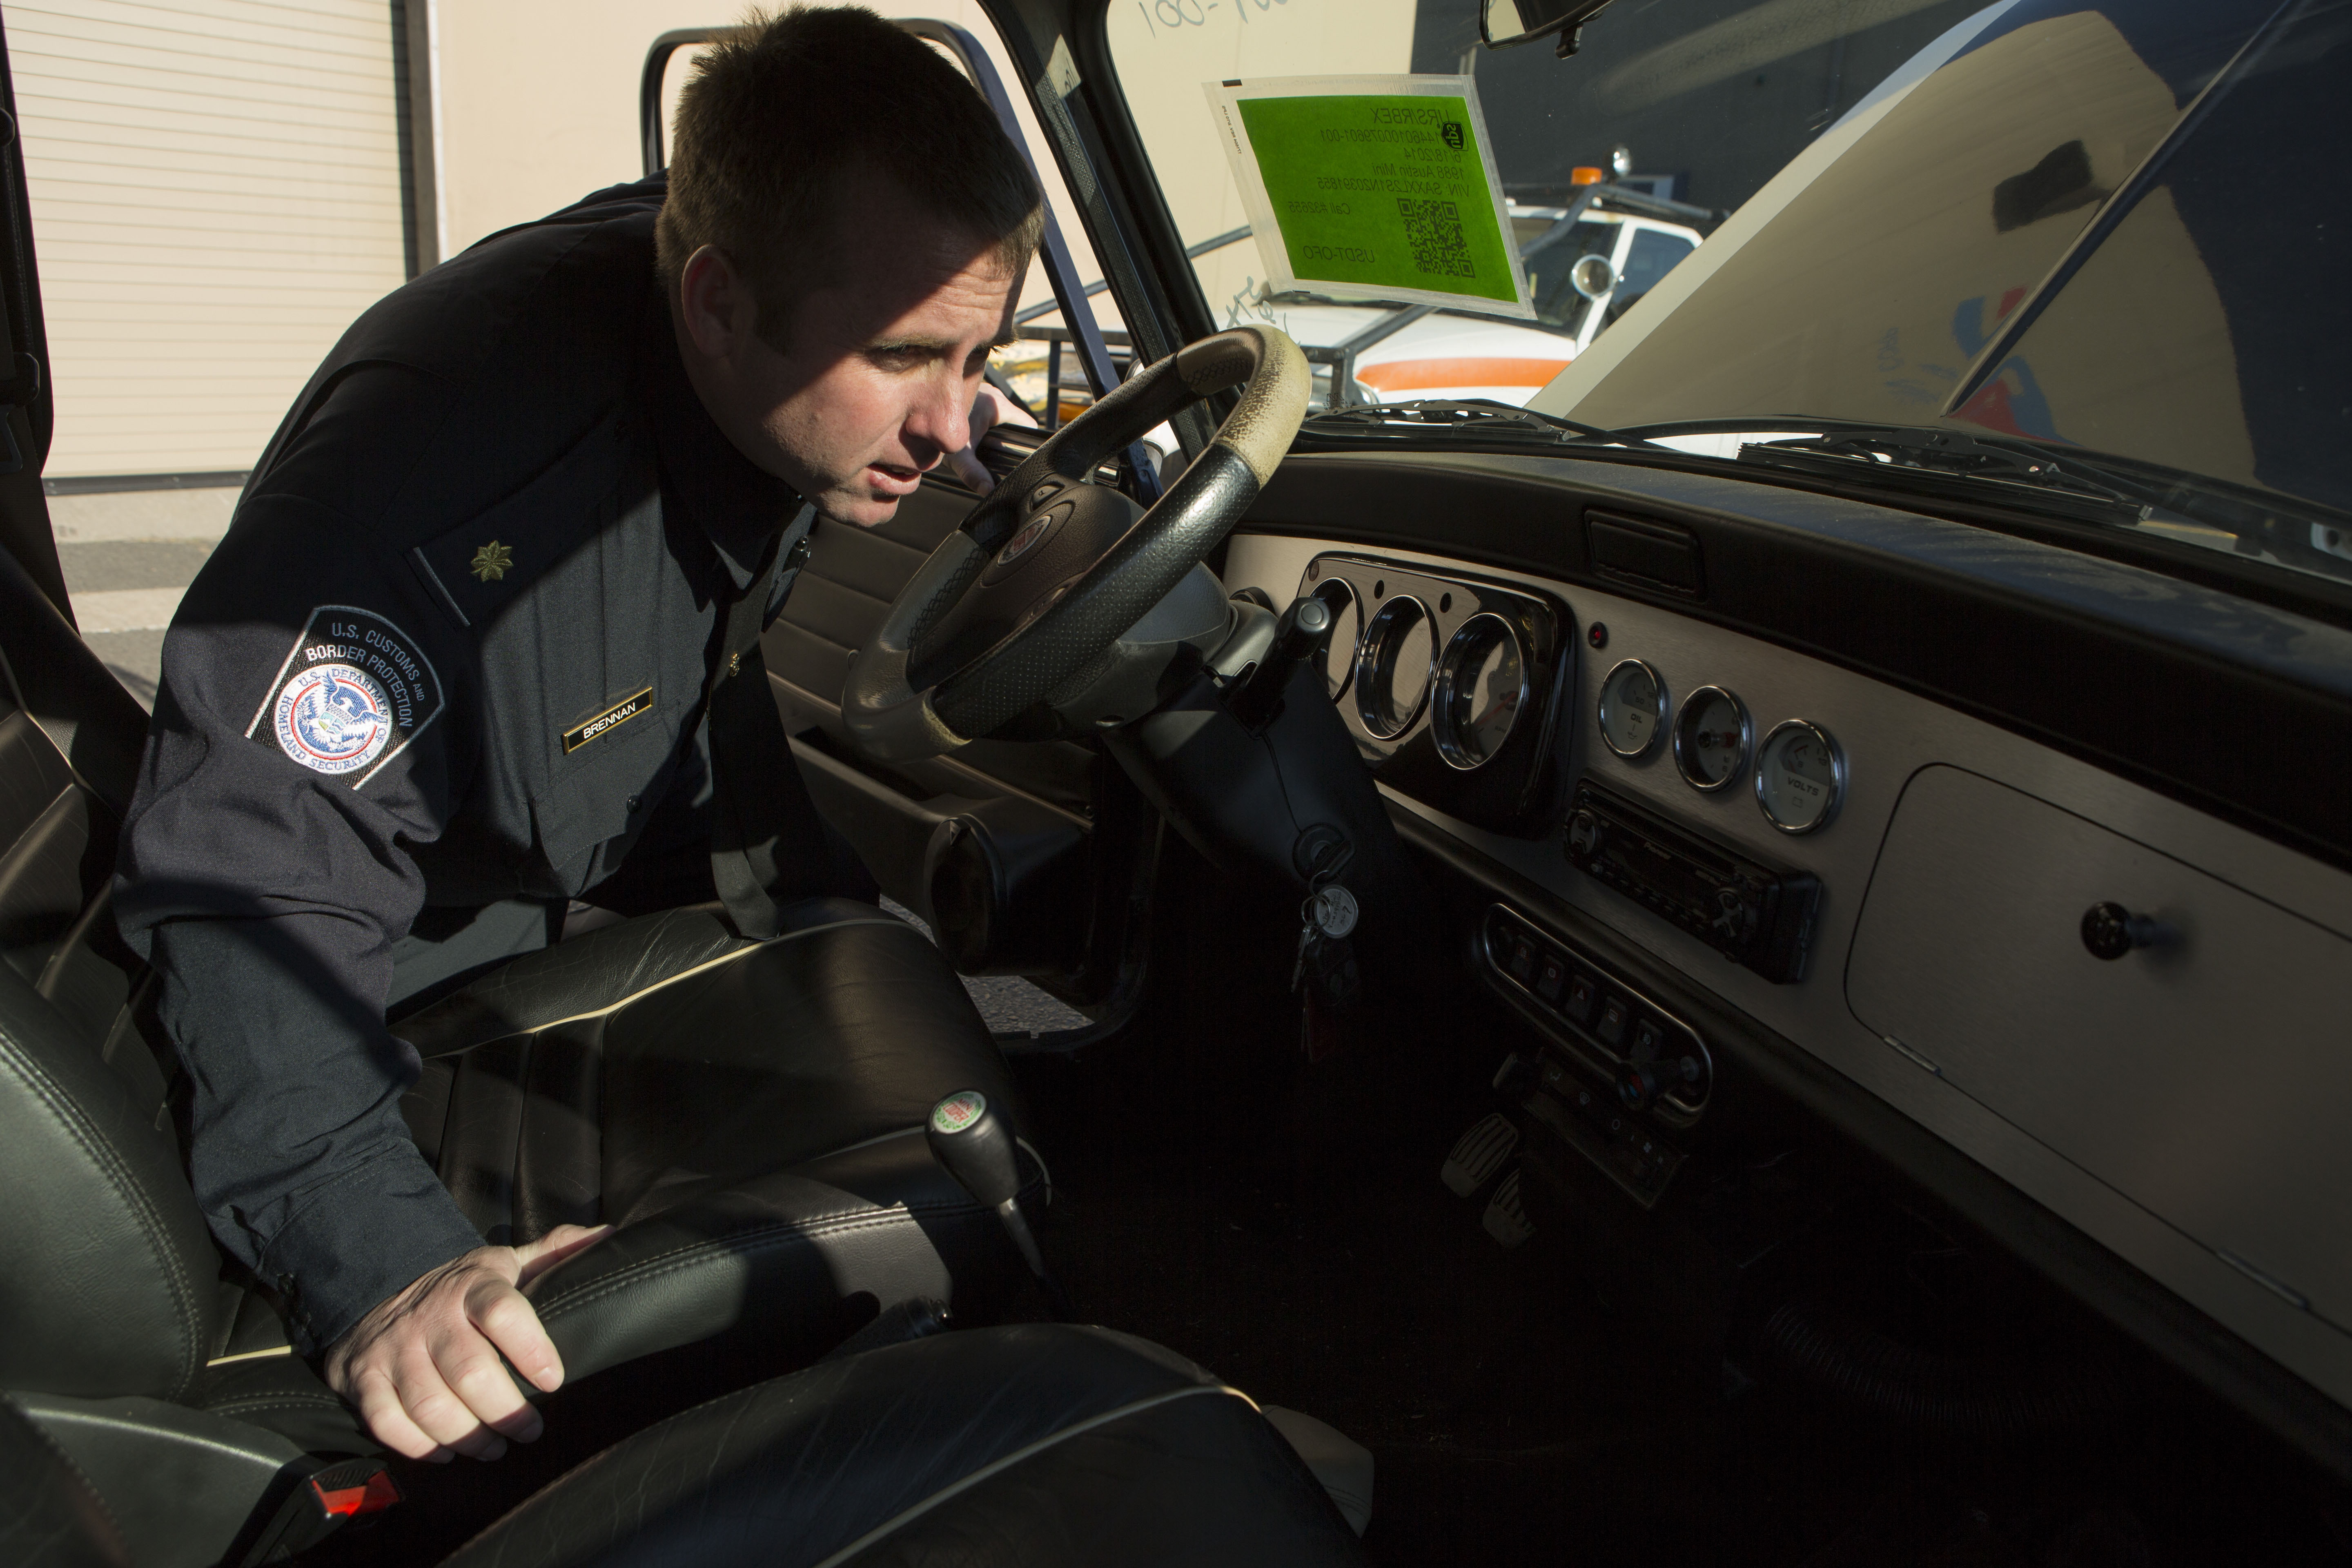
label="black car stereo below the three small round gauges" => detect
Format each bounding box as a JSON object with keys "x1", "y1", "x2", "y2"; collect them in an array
[{"x1": 1559, "y1": 783, "x2": 1820, "y2": 985}]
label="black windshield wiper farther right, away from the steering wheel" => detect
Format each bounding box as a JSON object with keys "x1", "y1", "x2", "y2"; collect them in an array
[{"x1": 1738, "y1": 421, "x2": 2154, "y2": 524}]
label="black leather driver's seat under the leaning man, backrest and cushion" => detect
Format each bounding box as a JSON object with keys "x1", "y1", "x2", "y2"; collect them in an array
[{"x1": 0, "y1": 552, "x2": 1035, "y2": 1450}]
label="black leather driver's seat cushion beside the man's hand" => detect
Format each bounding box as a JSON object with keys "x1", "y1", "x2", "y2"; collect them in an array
[{"x1": 395, "y1": 898, "x2": 1042, "y2": 1373}]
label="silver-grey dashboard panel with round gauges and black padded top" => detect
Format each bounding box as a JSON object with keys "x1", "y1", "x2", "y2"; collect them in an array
[{"x1": 1223, "y1": 446, "x2": 2352, "y2": 1434}]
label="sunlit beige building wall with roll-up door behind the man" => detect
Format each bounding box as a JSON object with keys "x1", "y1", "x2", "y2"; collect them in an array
[{"x1": 7, "y1": 0, "x2": 1166, "y2": 477}]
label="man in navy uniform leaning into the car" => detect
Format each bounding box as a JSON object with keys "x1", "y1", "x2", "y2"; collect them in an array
[{"x1": 118, "y1": 9, "x2": 1042, "y2": 1460}]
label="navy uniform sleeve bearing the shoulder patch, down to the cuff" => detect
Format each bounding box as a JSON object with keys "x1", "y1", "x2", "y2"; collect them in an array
[{"x1": 115, "y1": 491, "x2": 482, "y2": 1354}]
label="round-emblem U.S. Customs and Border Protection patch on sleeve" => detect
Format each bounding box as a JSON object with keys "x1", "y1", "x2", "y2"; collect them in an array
[{"x1": 245, "y1": 604, "x2": 445, "y2": 790}]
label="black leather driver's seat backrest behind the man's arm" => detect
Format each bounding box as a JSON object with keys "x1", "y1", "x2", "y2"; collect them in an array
[{"x1": 0, "y1": 552, "x2": 221, "y2": 1399}]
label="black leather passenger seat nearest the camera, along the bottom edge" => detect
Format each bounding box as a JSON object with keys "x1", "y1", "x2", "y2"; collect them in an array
[{"x1": 0, "y1": 1326, "x2": 1362, "y2": 1568}]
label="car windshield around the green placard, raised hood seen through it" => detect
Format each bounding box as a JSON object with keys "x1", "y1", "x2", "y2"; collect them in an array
[{"x1": 1108, "y1": 0, "x2": 2352, "y2": 588}]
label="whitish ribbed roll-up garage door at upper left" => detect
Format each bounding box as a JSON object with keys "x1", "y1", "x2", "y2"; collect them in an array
[{"x1": 7, "y1": 0, "x2": 407, "y2": 475}]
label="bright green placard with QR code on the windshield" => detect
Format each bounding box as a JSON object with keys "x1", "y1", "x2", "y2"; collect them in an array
[{"x1": 1209, "y1": 75, "x2": 1534, "y2": 317}]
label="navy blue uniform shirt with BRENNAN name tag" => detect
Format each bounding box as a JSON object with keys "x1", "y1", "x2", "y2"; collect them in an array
[{"x1": 115, "y1": 179, "x2": 802, "y2": 1352}]
